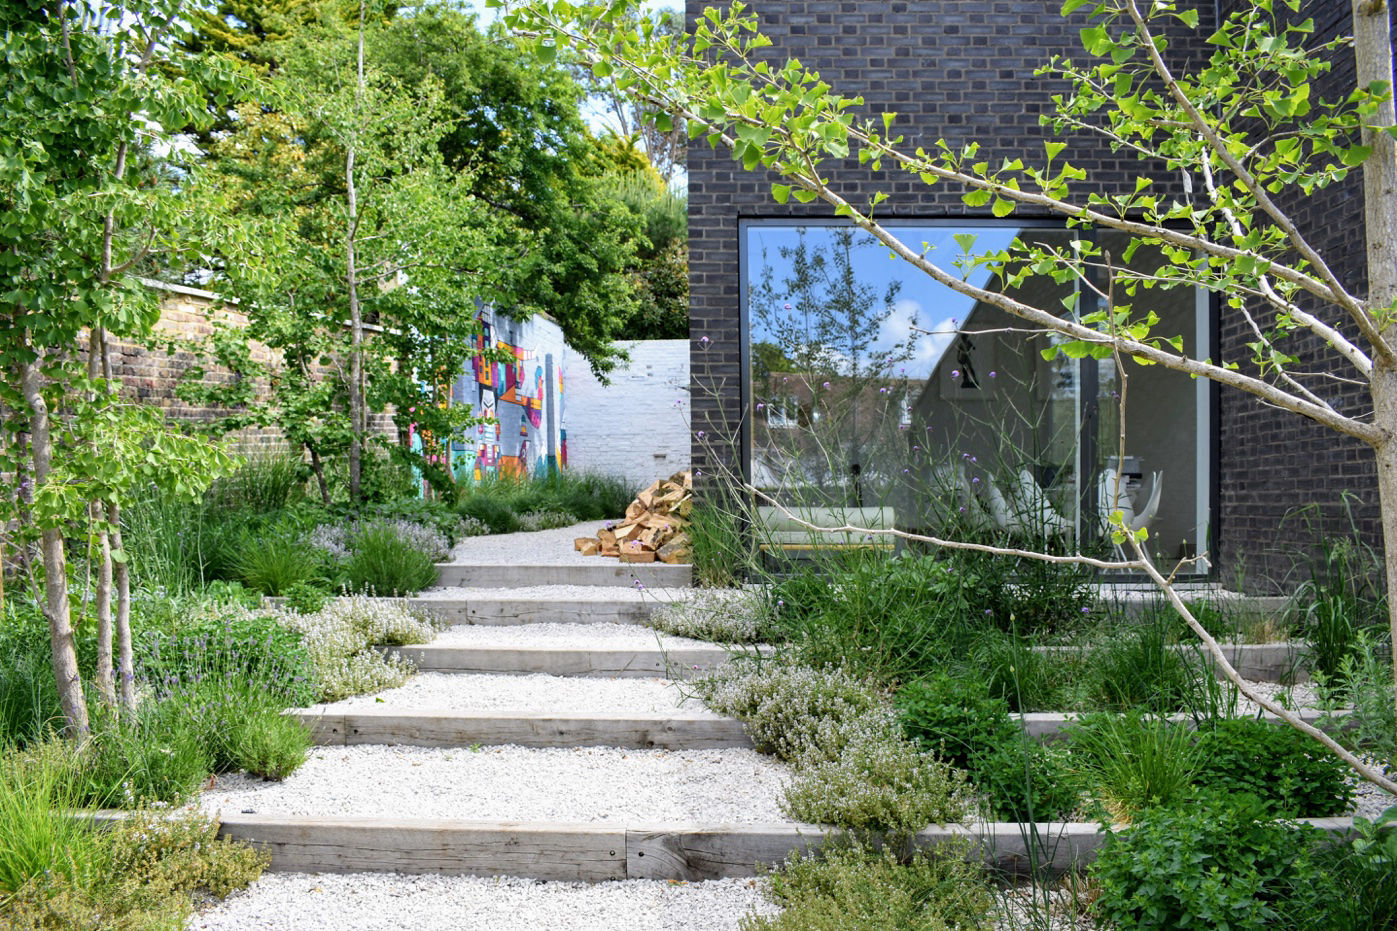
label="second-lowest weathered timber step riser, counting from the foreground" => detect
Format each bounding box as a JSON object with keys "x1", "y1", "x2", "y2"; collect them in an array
[{"x1": 292, "y1": 707, "x2": 752, "y2": 749}]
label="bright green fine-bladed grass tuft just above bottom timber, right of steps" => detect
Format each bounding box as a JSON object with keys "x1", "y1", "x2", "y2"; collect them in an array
[{"x1": 1069, "y1": 712, "x2": 1207, "y2": 816}]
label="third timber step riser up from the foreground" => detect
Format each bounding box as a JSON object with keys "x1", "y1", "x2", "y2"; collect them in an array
[{"x1": 393, "y1": 643, "x2": 729, "y2": 678}]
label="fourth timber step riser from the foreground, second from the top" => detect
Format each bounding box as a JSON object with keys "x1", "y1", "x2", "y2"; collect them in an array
[{"x1": 408, "y1": 586, "x2": 675, "y2": 626}]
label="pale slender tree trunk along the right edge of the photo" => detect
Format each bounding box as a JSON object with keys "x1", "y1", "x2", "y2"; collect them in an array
[{"x1": 1352, "y1": 0, "x2": 1397, "y2": 721}]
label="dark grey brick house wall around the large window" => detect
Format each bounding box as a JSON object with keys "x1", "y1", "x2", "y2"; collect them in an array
[{"x1": 687, "y1": 0, "x2": 1376, "y2": 587}]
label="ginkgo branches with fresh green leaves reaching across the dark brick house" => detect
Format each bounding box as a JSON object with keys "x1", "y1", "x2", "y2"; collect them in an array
[{"x1": 503, "y1": 0, "x2": 1397, "y2": 791}]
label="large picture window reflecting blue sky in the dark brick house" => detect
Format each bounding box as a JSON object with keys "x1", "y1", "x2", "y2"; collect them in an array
[{"x1": 742, "y1": 222, "x2": 1211, "y2": 570}]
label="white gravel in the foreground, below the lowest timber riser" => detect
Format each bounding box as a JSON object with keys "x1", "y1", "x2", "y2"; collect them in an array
[{"x1": 186, "y1": 872, "x2": 775, "y2": 931}]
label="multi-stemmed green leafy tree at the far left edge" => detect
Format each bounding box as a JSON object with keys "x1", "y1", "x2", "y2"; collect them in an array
[{"x1": 0, "y1": 0, "x2": 253, "y2": 734}]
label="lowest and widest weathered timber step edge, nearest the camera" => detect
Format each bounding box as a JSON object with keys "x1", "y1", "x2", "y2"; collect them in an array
[{"x1": 219, "y1": 814, "x2": 1352, "y2": 882}]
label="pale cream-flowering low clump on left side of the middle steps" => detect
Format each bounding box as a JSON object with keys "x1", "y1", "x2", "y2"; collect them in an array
[{"x1": 285, "y1": 594, "x2": 437, "y2": 702}]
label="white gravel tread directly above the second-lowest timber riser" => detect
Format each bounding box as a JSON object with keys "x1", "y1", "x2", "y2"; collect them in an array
[{"x1": 314, "y1": 672, "x2": 718, "y2": 717}]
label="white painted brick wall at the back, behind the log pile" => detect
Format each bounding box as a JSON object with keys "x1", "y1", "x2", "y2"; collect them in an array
[{"x1": 563, "y1": 340, "x2": 690, "y2": 485}]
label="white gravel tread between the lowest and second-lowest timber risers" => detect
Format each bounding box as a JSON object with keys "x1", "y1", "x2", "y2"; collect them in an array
[{"x1": 200, "y1": 746, "x2": 789, "y2": 823}]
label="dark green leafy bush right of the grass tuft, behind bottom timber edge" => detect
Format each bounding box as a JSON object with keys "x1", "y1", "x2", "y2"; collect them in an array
[{"x1": 1197, "y1": 719, "x2": 1352, "y2": 818}]
